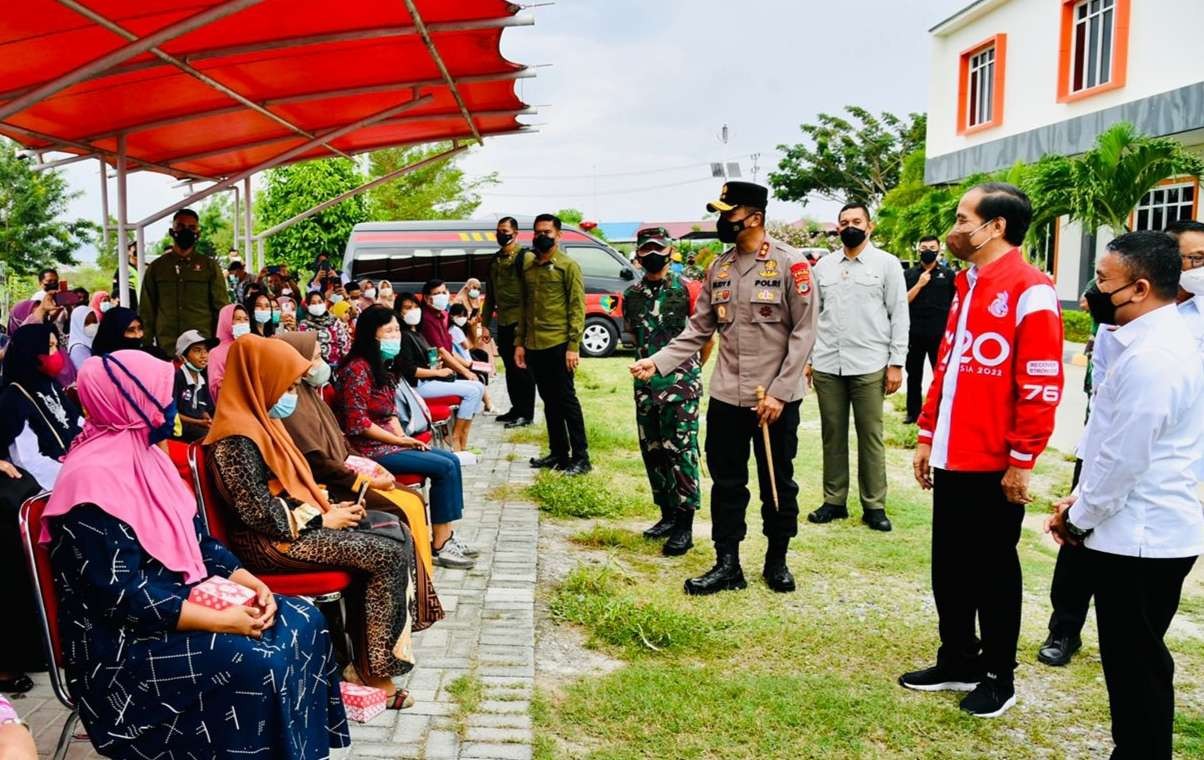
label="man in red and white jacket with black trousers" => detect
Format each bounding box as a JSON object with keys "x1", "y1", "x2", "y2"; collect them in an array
[{"x1": 899, "y1": 183, "x2": 1062, "y2": 718}]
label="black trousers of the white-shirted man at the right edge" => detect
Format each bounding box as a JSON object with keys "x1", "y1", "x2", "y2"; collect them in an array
[{"x1": 1080, "y1": 548, "x2": 1196, "y2": 760}]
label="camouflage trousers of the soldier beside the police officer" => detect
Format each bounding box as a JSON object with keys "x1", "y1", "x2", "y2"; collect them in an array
[{"x1": 636, "y1": 393, "x2": 702, "y2": 514}]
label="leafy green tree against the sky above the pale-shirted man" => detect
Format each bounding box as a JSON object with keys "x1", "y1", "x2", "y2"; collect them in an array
[{"x1": 769, "y1": 106, "x2": 927, "y2": 207}]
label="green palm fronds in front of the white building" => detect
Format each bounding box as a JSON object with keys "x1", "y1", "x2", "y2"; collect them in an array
[{"x1": 1022, "y1": 122, "x2": 1204, "y2": 235}]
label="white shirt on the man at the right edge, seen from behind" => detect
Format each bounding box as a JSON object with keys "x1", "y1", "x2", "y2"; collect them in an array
[{"x1": 1068, "y1": 305, "x2": 1204, "y2": 558}]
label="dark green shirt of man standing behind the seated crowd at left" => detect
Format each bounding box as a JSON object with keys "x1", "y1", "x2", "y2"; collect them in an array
[{"x1": 138, "y1": 249, "x2": 230, "y2": 355}]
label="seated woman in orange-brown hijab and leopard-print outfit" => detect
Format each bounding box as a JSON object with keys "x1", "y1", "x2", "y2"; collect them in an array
[{"x1": 205, "y1": 335, "x2": 417, "y2": 709}]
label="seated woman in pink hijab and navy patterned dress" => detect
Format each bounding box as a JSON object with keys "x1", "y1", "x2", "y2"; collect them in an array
[{"x1": 41, "y1": 350, "x2": 350, "y2": 760}]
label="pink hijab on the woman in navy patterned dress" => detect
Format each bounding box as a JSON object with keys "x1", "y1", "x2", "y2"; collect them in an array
[{"x1": 41, "y1": 350, "x2": 206, "y2": 583}]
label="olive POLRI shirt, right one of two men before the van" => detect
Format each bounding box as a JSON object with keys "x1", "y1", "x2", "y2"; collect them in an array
[{"x1": 515, "y1": 248, "x2": 585, "y2": 350}]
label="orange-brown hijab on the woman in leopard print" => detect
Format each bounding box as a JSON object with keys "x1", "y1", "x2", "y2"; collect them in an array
[{"x1": 205, "y1": 335, "x2": 330, "y2": 511}]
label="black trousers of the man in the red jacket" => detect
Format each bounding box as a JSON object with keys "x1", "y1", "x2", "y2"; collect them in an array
[{"x1": 932, "y1": 470, "x2": 1025, "y2": 679}]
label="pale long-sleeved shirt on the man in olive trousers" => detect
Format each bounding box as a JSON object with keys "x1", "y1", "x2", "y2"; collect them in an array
[{"x1": 811, "y1": 243, "x2": 910, "y2": 376}]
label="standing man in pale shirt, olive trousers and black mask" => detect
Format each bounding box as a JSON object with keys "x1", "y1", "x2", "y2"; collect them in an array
[{"x1": 805, "y1": 202, "x2": 909, "y2": 531}]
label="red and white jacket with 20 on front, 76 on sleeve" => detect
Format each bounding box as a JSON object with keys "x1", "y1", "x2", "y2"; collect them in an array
[{"x1": 919, "y1": 248, "x2": 1062, "y2": 472}]
